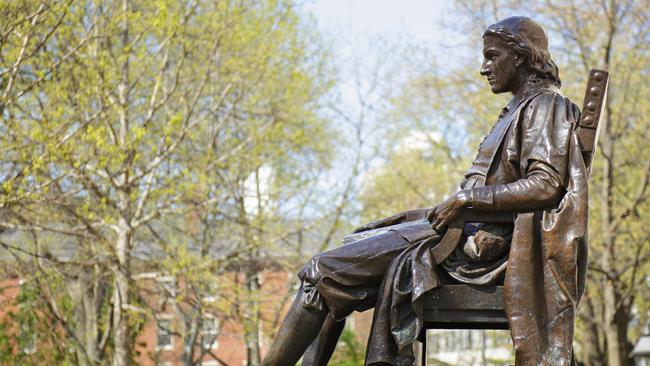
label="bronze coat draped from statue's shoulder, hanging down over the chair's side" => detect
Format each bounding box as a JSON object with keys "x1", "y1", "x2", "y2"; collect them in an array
[{"x1": 495, "y1": 93, "x2": 588, "y2": 366}]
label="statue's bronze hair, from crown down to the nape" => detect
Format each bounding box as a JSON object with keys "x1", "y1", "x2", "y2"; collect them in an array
[{"x1": 483, "y1": 17, "x2": 562, "y2": 88}]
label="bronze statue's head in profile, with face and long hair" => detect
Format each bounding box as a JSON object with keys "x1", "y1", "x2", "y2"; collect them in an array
[{"x1": 481, "y1": 17, "x2": 561, "y2": 93}]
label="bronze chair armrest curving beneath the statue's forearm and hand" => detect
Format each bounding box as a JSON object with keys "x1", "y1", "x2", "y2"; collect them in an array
[{"x1": 431, "y1": 208, "x2": 515, "y2": 264}]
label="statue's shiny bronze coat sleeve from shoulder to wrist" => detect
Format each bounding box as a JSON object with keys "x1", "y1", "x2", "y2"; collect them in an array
[{"x1": 471, "y1": 92, "x2": 580, "y2": 212}]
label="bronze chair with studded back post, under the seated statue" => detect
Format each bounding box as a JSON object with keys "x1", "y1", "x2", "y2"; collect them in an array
[{"x1": 419, "y1": 69, "x2": 608, "y2": 365}]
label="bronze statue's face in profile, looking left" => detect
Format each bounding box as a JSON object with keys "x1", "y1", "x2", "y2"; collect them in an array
[{"x1": 481, "y1": 35, "x2": 521, "y2": 94}]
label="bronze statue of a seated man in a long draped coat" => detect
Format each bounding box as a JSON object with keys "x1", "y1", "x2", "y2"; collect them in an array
[{"x1": 263, "y1": 17, "x2": 587, "y2": 366}]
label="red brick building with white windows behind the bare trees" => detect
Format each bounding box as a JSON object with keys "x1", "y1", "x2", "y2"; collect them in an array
[{"x1": 0, "y1": 270, "x2": 372, "y2": 366}]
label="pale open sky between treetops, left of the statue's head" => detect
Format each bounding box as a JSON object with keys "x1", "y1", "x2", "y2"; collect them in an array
[{"x1": 303, "y1": 0, "x2": 480, "y2": 114}]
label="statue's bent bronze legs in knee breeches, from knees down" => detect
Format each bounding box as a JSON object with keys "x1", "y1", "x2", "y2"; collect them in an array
[{"x1": 262, "y1": 231, "x2": 410, "y2": 366}]
